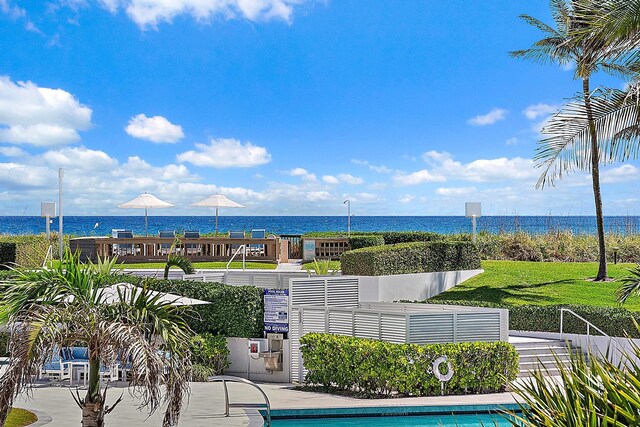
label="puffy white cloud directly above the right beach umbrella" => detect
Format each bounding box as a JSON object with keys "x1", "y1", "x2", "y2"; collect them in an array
[{"x1": 177, "y1": 138, "x2": 271, "y2": 169}]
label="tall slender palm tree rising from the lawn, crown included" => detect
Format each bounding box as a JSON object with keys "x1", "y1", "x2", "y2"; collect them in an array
[{"x1": 511, "y1": 0, "x2": 629, "y2": 280}]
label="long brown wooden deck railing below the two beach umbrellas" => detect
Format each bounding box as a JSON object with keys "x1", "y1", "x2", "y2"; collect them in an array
[{"x1": 69, "y1": 237, "x2": 280, "y2": 263}]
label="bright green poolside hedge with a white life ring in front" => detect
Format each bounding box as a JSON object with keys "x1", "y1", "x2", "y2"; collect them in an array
[{"x1": 300, "y1": 333, "x2": 519, "y2": 397}]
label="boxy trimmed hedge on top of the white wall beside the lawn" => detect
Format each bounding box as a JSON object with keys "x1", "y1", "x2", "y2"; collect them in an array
[{"x1": 340, "y1": 242, "x2": 480, "y2": 276}]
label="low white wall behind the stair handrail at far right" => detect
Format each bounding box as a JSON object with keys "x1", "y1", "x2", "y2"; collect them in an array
[{"x1": 509, "y1": 331, "x2": 640, "y2": 364}]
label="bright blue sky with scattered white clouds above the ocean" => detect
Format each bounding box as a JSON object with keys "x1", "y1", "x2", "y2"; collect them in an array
[{"x1": 0, "y1": 0, "x2": 640, "y2": 215}]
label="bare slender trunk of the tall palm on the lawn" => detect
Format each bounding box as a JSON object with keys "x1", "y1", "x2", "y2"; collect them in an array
[{"x1": 582, "y1": 78, "x2": 607, "y2": 281}]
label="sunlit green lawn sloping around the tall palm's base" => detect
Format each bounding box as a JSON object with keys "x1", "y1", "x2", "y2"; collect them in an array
[{"x1": 434, "y1": 261, "x2": 640, "y2": 311}]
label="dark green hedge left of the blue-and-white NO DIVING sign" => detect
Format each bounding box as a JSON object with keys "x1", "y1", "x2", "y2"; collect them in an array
[{"x1": 97, "y1": 276, "x2": 264, "y2": 338}]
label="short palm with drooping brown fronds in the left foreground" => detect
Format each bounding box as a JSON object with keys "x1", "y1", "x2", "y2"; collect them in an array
[{"x1": 0, "y1": 255, "x2": 192, "y2": 427}]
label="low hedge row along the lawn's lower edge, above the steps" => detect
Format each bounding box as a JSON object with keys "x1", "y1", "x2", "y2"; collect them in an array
[{"x1": 426, "y1": 299, "x2": 640, "y2": 338}]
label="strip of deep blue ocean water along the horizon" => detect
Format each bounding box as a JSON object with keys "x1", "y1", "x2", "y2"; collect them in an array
[{"x1": 0, "y1": 216, "x2": 640, "y2": 236}]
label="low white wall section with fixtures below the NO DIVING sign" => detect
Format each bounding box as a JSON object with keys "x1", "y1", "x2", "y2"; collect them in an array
[{"x1": 225, "y1": 338, "x2": 291, "y2": 383}]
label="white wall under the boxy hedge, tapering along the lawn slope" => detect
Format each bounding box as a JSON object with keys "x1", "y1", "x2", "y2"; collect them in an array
[{"x1": 358, "y1": 269, "x2": 484, "y2": 302}]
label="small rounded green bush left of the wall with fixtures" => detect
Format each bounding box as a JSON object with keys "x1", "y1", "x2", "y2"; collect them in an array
[{"x1": 191, "y1": 332, "x2": 229, "y2": 382}]
